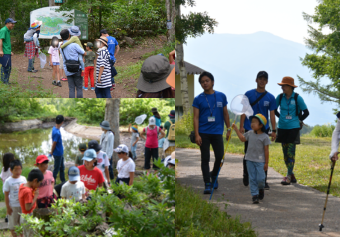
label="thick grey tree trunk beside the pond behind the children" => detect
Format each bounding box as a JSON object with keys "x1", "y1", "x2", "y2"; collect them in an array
[{"x1": 105, "y1": 99, "x2": 120, "y2": 166}]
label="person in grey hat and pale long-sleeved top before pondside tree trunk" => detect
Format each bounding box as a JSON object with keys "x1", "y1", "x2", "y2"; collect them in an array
[{"x1": 100, "y1": 121, "x2": 115, "y2": 182}]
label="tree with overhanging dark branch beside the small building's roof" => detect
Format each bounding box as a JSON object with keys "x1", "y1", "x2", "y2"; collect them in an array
[{"x1": 175, "y1": 0, "x2": 217, "y2": 114}]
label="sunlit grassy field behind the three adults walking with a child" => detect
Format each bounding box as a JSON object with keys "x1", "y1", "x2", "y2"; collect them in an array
[{"x1": 176, "y1": 132, "x2": 340, "y2": 197}]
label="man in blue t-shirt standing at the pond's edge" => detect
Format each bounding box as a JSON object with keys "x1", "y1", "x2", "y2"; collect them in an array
[{"x1": 50, "y1": 115, "x2": 65, "y2": 182}]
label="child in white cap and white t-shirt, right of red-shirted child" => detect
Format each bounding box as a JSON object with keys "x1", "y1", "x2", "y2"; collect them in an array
[{"x1": 114, "y1": 144, "x2": 136, "y2": 186}]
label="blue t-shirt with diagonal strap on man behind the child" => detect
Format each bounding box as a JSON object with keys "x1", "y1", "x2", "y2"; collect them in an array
[{"x1": 243, "y1": 89, "x2": 277, "y2": 130}]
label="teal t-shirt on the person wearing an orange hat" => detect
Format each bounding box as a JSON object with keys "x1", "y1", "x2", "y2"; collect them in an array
[{"x1": 276, "y1": 92, "x2": 307, "y2": 129}]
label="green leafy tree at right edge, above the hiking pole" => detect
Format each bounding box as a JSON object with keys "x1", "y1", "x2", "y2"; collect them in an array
[{"x1": 298, "y1": 0, "x2": 340, "y2": 107}]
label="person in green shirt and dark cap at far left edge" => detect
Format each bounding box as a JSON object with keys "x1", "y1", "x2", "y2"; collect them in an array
[{"x1": 0, "y1": 18, "x2": 17, "y2": 84}]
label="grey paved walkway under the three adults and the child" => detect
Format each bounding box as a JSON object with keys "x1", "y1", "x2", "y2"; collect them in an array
[{"x1": 176, "y1": 148, "x2": 340, "y2": 237}]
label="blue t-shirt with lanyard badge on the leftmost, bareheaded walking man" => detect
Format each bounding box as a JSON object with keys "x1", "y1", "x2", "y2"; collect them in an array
[{"x1": 192, "y1": 91, "x2": 228, "y2": 135}]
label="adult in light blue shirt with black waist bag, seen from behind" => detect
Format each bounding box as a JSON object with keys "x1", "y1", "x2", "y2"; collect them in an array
[{"x1": 60, "y1": 29, "x2": 85, "y2": 98}]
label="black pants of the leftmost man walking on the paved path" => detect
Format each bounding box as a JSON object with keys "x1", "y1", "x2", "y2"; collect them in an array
[{"x1": 200, "y1": 133, "x2": 224, "y2": 183}]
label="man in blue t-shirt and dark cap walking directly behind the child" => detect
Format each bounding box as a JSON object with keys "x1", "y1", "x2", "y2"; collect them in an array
[{"x1": 240, "y1": 71, "x2": 277, "y2": 190}]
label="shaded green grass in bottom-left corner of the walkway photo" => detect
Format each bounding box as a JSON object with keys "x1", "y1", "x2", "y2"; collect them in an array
[{"x1": 175, "y1": 182, "x2": 256, "y2": 237}]
